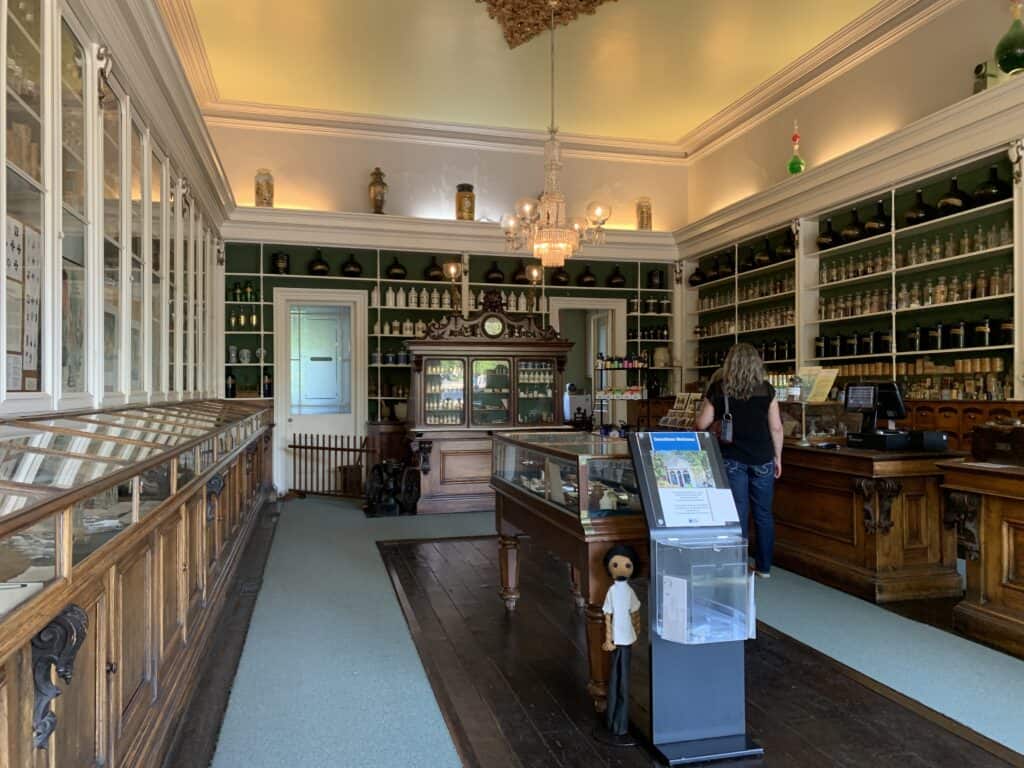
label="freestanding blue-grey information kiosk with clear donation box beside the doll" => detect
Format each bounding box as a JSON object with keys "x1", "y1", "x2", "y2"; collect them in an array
[{"x1": 630, "y1": 432, "x2": 764, "y2": 765}]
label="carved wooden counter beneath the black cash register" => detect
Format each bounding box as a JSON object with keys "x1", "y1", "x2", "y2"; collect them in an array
[{"x1": 770, "y1": 444, "x2": 963, "y2": 603}]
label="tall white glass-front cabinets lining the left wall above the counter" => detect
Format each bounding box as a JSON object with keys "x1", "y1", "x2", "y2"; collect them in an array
[{"x1": 0, "y1": 0, "x2": 217, "y2": 415}]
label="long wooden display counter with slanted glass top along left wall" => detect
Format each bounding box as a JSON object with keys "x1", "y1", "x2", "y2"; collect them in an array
[{"x1": 0, "y1": 400, "x2": 272, "y2": 768}]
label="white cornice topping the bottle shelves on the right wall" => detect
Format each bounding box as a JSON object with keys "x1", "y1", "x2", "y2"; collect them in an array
[{"x1": 674, "y1": 78, "x2": 1024, "y2": 259}]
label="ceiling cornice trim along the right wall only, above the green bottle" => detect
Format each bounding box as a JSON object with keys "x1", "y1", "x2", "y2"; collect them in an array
[{"x1": 678, "y1": 0, "x2": 964, "y2": 159}]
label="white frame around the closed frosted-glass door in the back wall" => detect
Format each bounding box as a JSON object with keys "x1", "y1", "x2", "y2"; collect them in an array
[{"x1": 273, "y1": 288, "x2": 370, "y2": 493}]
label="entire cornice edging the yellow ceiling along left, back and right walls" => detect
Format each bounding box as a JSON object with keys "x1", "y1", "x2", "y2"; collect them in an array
[{"x1": 160, "y1": 0, "x2": 963, "y2": 165}]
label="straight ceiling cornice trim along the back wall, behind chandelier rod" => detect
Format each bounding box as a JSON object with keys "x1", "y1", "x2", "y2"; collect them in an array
[{"x1": 204, "y1": 100, "x2": 687, "y2": 165}]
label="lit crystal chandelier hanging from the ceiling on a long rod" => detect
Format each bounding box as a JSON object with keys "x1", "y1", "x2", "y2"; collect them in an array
[{"x1": 502, "y1": 0, "x2": 611, "y2": 267}]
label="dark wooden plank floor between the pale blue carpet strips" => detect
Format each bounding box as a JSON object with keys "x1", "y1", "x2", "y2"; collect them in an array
[{"x1": 380, "y1": 539, "x2": 1016, "y2": 768}]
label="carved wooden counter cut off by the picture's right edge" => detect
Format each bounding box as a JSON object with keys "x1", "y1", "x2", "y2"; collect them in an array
[{"x1": 939, "y1": 461, "x2": 1024, "y2": 657}]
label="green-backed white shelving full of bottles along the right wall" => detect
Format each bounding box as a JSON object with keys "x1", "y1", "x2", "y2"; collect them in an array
[{"x1": 683, "y1": 151, "x2": 1024, "y2": 397}]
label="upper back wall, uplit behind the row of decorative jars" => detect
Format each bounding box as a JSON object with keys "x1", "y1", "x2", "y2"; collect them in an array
[{"x1": 210, "y1": 120, "x2": 687, "y2": 230}]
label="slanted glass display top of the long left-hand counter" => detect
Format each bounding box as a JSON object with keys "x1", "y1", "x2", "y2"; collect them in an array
[{"x1": 0, "y1": 401, "x2": 270, "y2": 617}]
